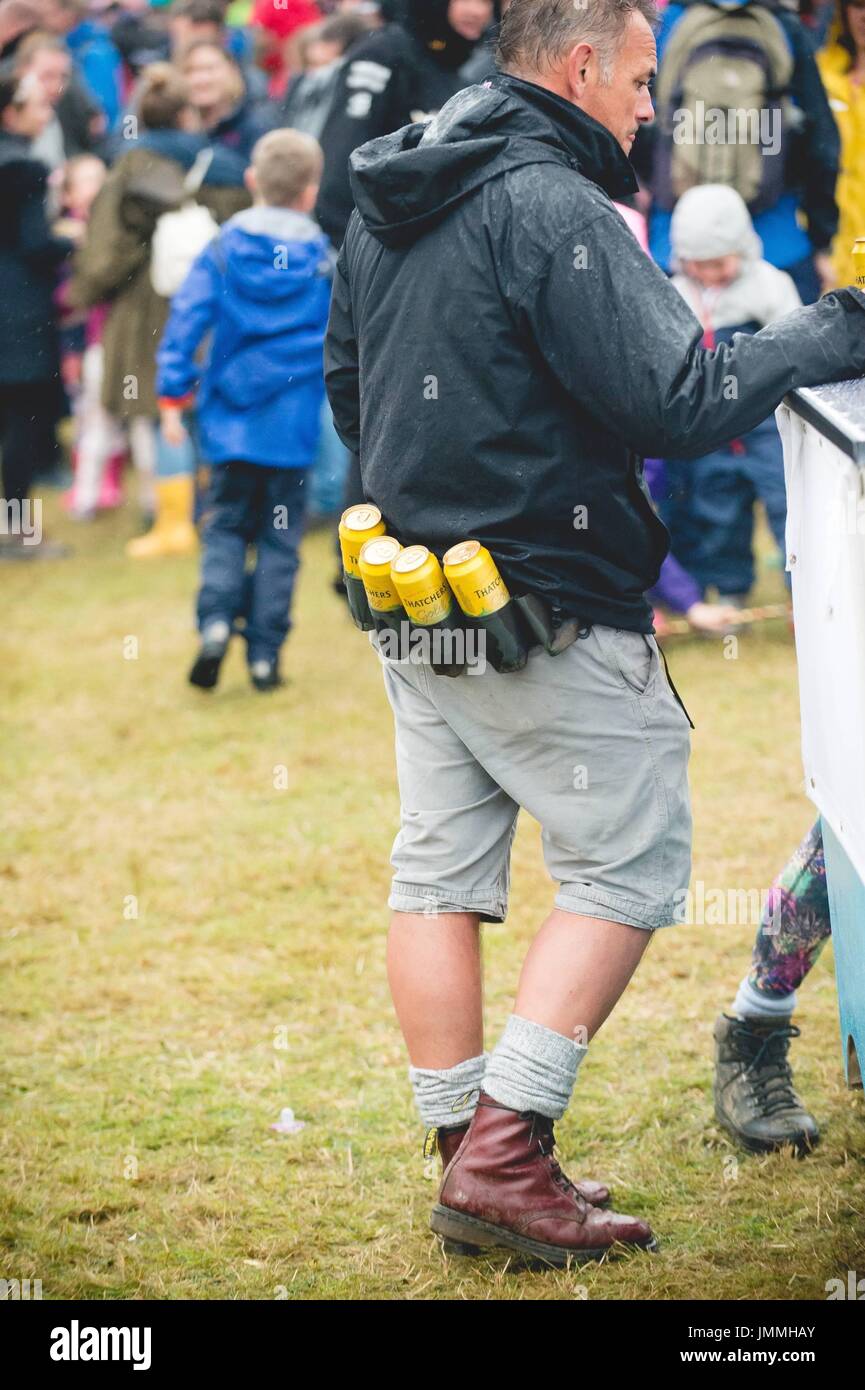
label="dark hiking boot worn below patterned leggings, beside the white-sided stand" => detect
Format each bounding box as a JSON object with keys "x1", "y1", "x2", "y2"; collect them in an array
[{"x1": 715, "y1": 1013, "x2": 820, "y2": 1154}]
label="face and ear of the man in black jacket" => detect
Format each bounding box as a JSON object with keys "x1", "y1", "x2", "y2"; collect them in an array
[{"x1": 569, "y1": 14, "x2": 658, "y2": 154}]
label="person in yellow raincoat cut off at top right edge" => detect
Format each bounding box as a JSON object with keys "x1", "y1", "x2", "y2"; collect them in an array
[{"x1": 816, "y1": 0, "x2": 865, "y2": 285}]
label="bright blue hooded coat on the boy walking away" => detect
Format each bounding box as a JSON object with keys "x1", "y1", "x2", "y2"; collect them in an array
[{"x1": 156, "y1": 207, "x2": 332, "y2": 468}]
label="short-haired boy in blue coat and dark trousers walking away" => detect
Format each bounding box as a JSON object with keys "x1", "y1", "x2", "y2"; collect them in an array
[{"x1": 157, "y1": 129, "x2": 332, "y2": 691}]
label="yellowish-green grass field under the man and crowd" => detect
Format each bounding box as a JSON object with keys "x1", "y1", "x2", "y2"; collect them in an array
[{"x1": 0, "y1": 494, "x2": 865, "y2": 1300}]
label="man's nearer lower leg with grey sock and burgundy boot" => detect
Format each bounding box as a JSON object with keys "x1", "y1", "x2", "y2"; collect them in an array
[{"x1": 430, "y1": 910, "x2": 656, "y2": 1265}]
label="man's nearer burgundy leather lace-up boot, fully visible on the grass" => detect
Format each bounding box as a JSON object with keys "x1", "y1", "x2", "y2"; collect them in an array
[{"x1": 430, "y1": 1091, "x2": 658, "y2": 1268}]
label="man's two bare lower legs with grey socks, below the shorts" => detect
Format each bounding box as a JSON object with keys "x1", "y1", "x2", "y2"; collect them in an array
[{"x1": 388, "y1": 910, "x2": 651, "y2": 1223}]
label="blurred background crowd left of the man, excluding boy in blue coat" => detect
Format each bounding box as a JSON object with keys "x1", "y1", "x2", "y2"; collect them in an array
[{"x1": 0, "y1": 0, "x2": 495, "y2": 559}]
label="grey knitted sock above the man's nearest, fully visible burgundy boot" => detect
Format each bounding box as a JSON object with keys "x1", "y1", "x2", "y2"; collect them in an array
[{"x1": 484, "y1": 1013, "x2": 588, "y2": 1120}]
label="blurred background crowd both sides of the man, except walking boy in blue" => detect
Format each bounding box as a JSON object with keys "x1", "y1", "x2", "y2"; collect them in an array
[{"x1": 0, "y1": 0, "x2": 865, "y2": 632}]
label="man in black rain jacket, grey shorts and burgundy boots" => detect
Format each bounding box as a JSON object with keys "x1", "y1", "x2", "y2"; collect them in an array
[{"x1": 327, "y1": 0, "x2": 865, "y2": 1264}]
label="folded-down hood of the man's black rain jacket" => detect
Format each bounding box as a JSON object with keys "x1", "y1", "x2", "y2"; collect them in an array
[{"x1": 350, "y1": 75, "x2": 637, "y2": 247}]
